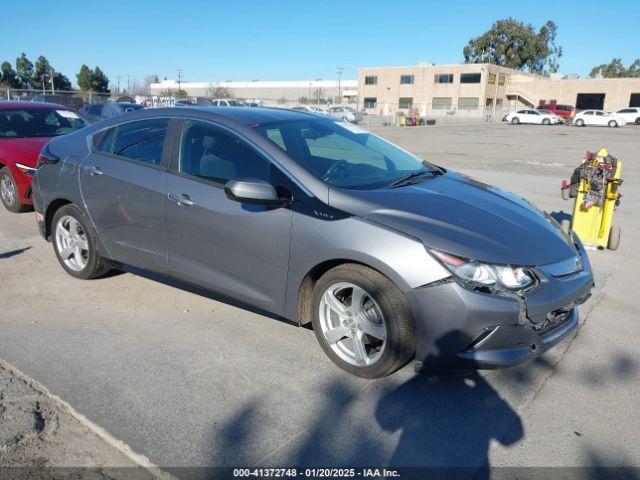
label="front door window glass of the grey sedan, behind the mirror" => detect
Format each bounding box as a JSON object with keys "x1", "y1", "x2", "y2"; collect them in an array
[{"x1": 179, "y1": 121, "x2": 272, "y2": 185}]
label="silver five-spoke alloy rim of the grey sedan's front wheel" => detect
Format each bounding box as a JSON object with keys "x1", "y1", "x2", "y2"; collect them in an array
[{"x1": 319, "y1": 282, "x2": 387, "y2": 367}]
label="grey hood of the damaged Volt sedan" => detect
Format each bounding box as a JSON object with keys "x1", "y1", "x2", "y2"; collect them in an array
[{"x1": 329, "y1": 172, "x2": 576, "y2": 266}]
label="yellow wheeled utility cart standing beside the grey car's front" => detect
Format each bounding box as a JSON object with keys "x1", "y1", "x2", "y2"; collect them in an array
[{"x1": 562, "y1": 148, "x2": 622, "y2": 250}]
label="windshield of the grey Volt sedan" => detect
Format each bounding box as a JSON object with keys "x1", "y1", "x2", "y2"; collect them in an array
[{"x1": 253, "y1": 119, "x2": 441, "y2": 189}]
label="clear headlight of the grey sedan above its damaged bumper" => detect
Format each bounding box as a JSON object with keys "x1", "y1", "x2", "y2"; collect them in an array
[{"x1": 430, "y1": 250, "x2": 535, "y2": 291}]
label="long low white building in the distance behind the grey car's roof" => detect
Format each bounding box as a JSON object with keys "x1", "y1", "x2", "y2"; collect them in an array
[{"x1": 150, "y1": 80, "x2": 358, "y2": 103}]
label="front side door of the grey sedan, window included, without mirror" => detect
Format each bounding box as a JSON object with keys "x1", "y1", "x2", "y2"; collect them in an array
[{"x1": 166, "y1": 121, "x2": 292, "y2": 314}]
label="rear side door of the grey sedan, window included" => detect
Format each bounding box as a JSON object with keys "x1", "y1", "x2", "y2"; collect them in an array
[{"x1": 80, "y1": 118, "x2": 170, "y2": 273}]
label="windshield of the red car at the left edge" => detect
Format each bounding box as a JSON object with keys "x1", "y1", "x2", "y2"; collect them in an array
[{"x1": 0, "y1": 108, "x2": 89, "y2": 138}]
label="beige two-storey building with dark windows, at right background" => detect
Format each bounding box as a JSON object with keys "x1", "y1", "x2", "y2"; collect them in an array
[{"x1": 358, "y1": 63, "x2": 640, "y2": 115}]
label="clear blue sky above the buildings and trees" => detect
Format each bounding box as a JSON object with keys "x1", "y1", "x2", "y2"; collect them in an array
[{"x1": 0, "y1": 0, "x2": 640, "y2": 86}]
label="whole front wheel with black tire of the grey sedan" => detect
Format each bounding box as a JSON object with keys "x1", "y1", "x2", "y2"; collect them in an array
[{"x1": 312, "y1": 264, "x2": 415, "y2": 378}]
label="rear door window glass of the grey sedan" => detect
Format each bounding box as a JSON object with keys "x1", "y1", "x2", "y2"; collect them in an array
[{"x1": 113, "y1": 119, "x2": 169, "y2": 165}]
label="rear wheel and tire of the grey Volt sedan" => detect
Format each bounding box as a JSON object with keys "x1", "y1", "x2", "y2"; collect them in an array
[{"x1": 52, "y1": 205, "x2": 109, "y2": 280}]
